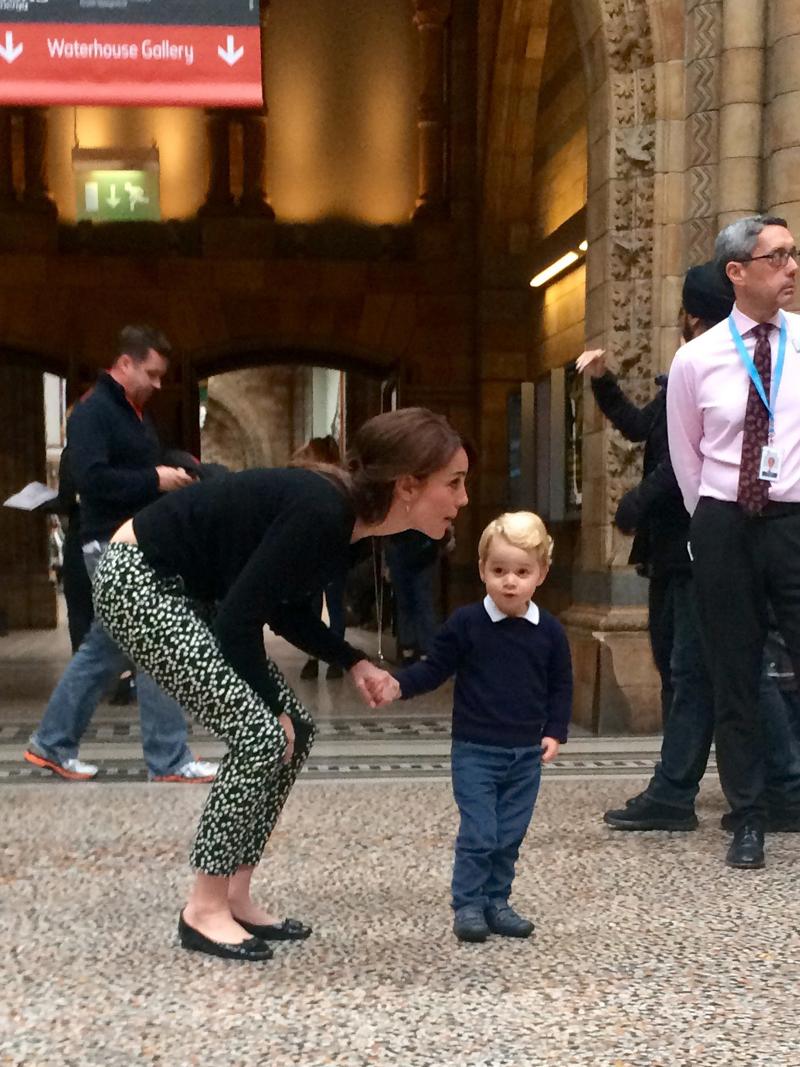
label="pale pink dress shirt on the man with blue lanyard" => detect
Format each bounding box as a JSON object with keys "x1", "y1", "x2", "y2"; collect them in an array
[{"x1": 667, "y1": 306, "x2": 800, "y2": 514}]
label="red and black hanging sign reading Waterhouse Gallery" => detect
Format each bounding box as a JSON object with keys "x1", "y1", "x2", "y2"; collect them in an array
[{"x1": 0, "y1": 0, "x2": 262, "y2": 108}]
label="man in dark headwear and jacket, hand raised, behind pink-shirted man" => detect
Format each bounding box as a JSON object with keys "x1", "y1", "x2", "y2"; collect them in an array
[{"x1": 578, "y1": 264, "x2": 800, "y2": 830}]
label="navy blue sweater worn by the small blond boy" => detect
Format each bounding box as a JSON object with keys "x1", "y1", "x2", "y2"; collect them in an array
[{"x1": 396, "y1": 603, "x2": 572, "y2": 748}]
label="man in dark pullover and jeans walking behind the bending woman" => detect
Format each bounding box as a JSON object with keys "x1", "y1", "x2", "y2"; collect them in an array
[{"x1": 25, "y1": 327, "x2": 217, "y2": 781}]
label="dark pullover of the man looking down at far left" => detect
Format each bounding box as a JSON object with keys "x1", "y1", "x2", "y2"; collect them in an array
[{"x1": 67, "y1": 371, "x2": 161, "y2": 544}]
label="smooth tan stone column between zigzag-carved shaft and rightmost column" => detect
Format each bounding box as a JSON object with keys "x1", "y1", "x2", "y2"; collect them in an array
[{"x1": 717, "y1": 0, "x2": 768, "y2": 228}]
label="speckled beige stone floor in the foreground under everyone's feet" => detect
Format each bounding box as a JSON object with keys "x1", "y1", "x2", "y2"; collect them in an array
[{"x1": 0, "y1": 776, "x2": 800, "y2": 1067}]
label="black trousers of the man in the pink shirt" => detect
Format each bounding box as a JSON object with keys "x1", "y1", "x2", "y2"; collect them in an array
[{"x1": 691, "y1": 497, "x2": 800, "y2": 823}]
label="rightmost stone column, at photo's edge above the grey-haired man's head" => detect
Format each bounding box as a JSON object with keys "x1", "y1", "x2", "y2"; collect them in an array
[{"x1": 764, "y1": 0, "x2": 800, "y2": 220}]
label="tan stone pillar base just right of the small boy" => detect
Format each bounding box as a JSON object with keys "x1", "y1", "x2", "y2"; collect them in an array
[{"x1": 561, "y1": 604, "x2": 661, "y2": 734}]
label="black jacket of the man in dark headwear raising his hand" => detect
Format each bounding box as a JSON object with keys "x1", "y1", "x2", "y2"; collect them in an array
[{"x1": 591, "y1": 371, "x2": 690, "y2": 575}]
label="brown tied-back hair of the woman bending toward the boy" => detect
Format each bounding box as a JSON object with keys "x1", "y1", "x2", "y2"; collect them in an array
[{"x1": 345, "y1": 408, "x2": 470, "y2": 523}]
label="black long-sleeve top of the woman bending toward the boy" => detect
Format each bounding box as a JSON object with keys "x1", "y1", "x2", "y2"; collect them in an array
[{"x1": 133, "y1": 467, "x2": 366, "y2": 706}]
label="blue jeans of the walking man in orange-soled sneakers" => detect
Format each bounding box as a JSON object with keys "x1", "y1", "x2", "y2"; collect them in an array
[{"x1": 31, "y1": 541, "x2": 192, "y2": 778}]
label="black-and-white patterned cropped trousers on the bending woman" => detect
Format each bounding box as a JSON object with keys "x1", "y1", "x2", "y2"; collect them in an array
[{"x1": 94, "y1": 543, "x2": 315, "y2": 875}]
